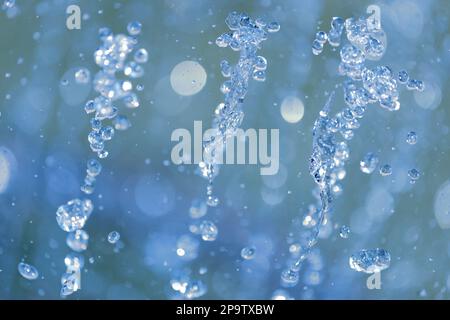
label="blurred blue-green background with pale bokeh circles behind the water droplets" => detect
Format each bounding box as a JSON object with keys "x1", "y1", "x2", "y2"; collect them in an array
[{"x1": 0, "y1": 0, "x2": 450, "y2": 299}]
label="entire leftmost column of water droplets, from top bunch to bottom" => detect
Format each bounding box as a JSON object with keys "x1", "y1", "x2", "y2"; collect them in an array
[{"x1": 56, "y1": 22, "x2": 148, "y2": 296}]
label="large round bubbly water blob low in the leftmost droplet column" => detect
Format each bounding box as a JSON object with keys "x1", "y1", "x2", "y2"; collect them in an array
[{"x1": 56, "y1": 199, "x2": 94, "y2": 232}]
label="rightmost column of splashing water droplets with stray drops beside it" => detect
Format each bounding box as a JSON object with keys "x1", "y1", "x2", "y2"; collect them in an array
[{"x1": 281, "y1": 11, "x2": 424, "y2": 287}]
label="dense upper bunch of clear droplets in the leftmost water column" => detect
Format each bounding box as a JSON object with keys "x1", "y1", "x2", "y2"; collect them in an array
[{"x1": 85, "y1": 22, "x2": 148, "y2": 159}]
